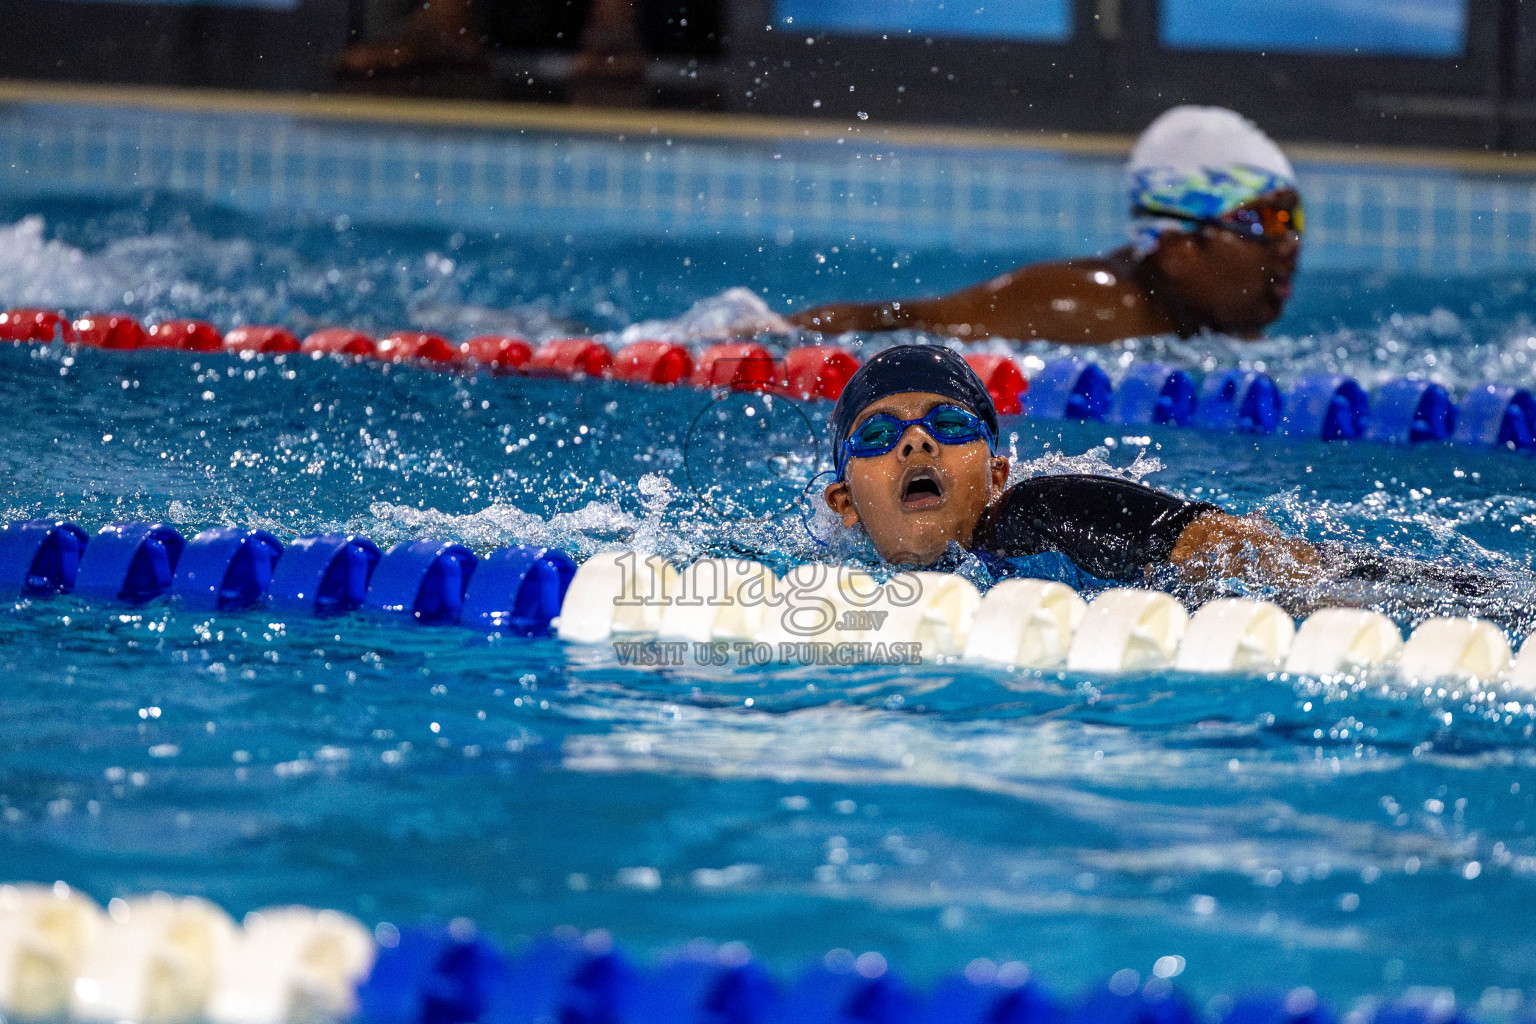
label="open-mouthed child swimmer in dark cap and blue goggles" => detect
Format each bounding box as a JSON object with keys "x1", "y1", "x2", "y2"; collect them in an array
[{"x1": 825, "y1": 345, "x2": 1318, "y2": 585}]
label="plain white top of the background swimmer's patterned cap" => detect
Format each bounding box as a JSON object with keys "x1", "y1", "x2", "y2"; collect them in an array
[{"x1": 1126, "y1": 106, "x2": 1296, "y2": 181}]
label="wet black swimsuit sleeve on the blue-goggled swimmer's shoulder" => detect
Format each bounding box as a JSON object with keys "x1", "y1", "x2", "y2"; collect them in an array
[{"x1": 971, "y1": 474, "x2": 1221, "y2": 586}]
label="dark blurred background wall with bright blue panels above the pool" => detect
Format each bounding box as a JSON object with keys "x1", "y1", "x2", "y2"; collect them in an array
[{"x1": 0, "y1": 0, "x2": 1536, "y2": 150}]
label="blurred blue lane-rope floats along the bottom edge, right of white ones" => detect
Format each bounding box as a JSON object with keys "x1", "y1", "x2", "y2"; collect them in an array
[{"x1": 345, "y1": 921, "x2": 1499, "y2": 1024}]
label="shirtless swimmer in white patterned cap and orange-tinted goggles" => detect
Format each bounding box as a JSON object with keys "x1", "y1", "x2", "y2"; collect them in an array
[{"x1": 790, "y1": 106, "x2": 1306, "y2": 344}]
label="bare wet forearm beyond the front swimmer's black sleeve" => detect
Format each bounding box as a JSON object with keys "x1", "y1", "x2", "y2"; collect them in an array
[{"x1": 1169, "y1": 511, "x2": 1322, "y2": 590}]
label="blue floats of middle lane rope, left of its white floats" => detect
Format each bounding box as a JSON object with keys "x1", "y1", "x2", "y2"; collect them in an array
[{"x1": 0, "y1": 519, "x2": 576, "y2": 637}]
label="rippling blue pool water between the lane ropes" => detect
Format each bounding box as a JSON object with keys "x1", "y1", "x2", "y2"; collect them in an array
[{"x1": 0, "y1": 186, "x2": 1536, "y2": 1019}]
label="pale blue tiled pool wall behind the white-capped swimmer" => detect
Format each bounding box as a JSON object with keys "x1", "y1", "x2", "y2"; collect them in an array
[{"x1": 0, "y1": 103, "x2": 1536, "y2": 275}]
